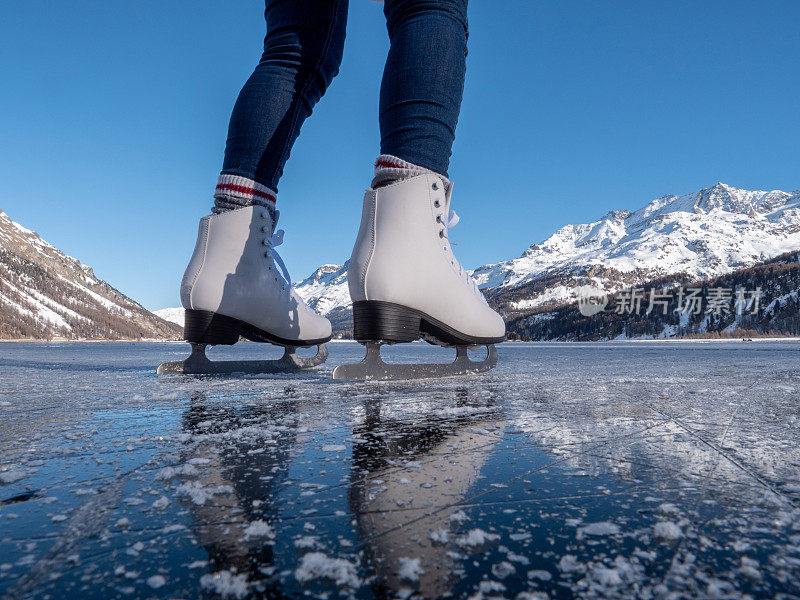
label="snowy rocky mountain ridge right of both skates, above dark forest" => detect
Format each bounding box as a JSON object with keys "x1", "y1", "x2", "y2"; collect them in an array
[{"x1": 473, "y1": 183, "x2": 800, "y2": 288}]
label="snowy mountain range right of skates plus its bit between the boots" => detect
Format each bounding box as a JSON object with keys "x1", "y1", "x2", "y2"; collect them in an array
[{"x1": 296, "y1": 183, "x2": 800, "y2": 320}]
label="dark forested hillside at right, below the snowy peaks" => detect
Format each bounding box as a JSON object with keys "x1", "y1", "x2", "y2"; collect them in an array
[{"x1": 505, "y1": 252, "x2": 800, "y2": 341}]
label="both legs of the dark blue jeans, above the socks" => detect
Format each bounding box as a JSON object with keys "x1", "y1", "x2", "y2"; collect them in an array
[{"x1": 222, "y1": 0, "x2": 467, "y2": 192}]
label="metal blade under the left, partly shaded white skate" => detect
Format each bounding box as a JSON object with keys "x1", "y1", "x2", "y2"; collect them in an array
[{"x1": 156, "y1": 344, "x2": 328, "y2": 375}]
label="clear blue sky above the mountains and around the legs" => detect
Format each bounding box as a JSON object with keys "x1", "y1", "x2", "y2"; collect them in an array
[{"x1": 0, "y1": 0, "x2": 800, "y2": 309}]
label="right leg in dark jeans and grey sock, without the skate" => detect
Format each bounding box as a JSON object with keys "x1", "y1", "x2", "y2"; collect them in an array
[{"x1": 376, "y1": 0, "x2": 467, "y2": 184}]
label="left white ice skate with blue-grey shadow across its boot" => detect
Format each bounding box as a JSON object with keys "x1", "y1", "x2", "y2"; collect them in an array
[{"x1": 158, "y1": 206, "x2": 331, "y2": 374}]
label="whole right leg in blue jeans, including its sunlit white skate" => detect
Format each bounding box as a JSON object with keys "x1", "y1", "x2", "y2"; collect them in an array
[{"x1": 333, "y1": 0, "x2": 505, "y2": 380}]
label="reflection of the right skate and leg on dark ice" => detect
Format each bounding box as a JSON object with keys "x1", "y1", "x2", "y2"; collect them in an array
[{"x1": 350, "y1": 389, "x2": 503, "y2": 598}]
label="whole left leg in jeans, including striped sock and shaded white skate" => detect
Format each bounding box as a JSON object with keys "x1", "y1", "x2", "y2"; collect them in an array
[{"x1": 175, "y1": 0, "x2": 347, "y2": 360}]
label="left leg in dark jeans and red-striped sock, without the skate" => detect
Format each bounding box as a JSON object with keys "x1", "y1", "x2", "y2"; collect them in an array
[{"x1": 215, "y1": 0, "x2": 348, "y2": 211}]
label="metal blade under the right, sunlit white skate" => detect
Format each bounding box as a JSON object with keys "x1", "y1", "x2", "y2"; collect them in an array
[{"x1": 333, "y1": 343, "x2": 497, "y2": 381}]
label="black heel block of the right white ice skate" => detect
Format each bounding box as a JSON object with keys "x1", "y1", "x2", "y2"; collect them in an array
[{"x1": 353, "y1": 300, "x2": 421, "y2": 342}]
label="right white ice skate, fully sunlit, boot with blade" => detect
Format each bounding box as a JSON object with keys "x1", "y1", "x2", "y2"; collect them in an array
[{"x1": 333, "y1": 173, "x2": 505, "y2": 380}]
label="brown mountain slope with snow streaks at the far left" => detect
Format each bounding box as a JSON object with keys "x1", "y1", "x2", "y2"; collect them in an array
[{"x1": 0, "y1": 210, "x2": 180, "y2": 339}]
